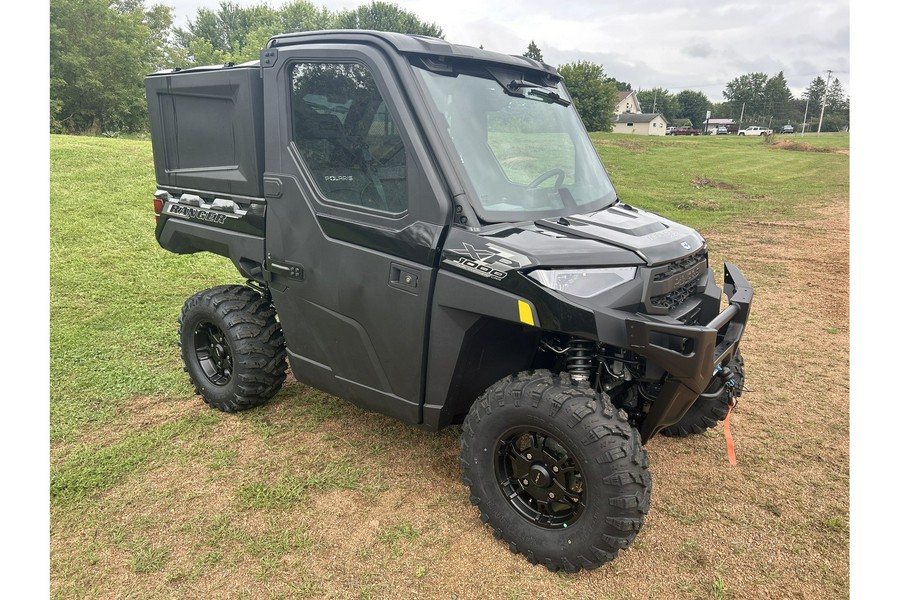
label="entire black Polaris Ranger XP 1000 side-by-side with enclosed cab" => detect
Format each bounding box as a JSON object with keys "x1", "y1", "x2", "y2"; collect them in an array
[{"x1": 146, "y1": 31, "x2": 753, "y2": 571}]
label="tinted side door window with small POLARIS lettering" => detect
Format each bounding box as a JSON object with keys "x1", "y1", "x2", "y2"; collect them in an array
[{"x1": 291, "y1": 63, "x2": 408, "y2": 213}]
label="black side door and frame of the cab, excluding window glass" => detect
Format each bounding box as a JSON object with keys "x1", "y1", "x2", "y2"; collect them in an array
[{"x1": 262, "y1": 41, "x2": 451, "y2": 424}]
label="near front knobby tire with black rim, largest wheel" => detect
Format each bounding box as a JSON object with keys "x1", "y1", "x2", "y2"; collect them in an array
[{"x1": 460, "y1": 371, "x2": 652, "y2": 572}]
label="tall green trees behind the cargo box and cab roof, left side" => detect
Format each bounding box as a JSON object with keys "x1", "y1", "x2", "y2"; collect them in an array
[{"x1": 50, "y1": 0, "x2": 443, "y2": 134}]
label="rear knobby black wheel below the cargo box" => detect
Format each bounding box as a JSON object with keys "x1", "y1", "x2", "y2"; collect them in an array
[{"x1": 178, "y1": 285, "x2": 287, "y2": 412}]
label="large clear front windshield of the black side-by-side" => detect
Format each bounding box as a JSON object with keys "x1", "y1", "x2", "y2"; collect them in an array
[{"x1": 415, "y1": 62, "x2": 616, "y2": 223}]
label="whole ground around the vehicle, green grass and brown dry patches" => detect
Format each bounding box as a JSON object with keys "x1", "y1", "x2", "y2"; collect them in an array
[{"x1": 50, "y1": 134, "x2": 849, "y2": 600}]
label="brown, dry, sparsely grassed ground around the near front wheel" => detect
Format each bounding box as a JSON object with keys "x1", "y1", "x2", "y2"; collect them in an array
[{"x1": 51, "y1": 198, "x2": 850, "y2": 600}]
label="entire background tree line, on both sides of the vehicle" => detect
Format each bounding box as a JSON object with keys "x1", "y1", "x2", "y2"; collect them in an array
[{"x1": 50, "y1": 0, "x2": 850, "y2": 134}]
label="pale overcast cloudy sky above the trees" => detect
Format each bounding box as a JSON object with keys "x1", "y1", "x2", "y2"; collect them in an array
[{"x1": 169, "y1": 0, "x2": 852, "y2": 102}]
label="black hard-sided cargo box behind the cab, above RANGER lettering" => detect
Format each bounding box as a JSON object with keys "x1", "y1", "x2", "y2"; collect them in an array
[{"x1": 144, "y1": 62, "x2": 264, "y2": 197}]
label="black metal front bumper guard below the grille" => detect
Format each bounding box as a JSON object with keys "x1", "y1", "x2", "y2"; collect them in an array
[{"x1": 625, "y1": 263, "x2": 753, "y2": 442}]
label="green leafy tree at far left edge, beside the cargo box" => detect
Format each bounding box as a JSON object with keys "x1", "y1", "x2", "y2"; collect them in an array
[{"x1": 50, "y1": 0, "x2": 172, "y2": 133}]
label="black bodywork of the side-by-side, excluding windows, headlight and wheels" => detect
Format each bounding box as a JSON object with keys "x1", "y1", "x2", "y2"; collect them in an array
[{"x1": 145, "y1": 31, "x2": 753, "y2": 441}]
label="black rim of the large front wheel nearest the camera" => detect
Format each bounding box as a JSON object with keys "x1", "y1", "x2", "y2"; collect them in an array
[{"x1": 494, "y1": 427, "x2": 587, "y2": 529}]
